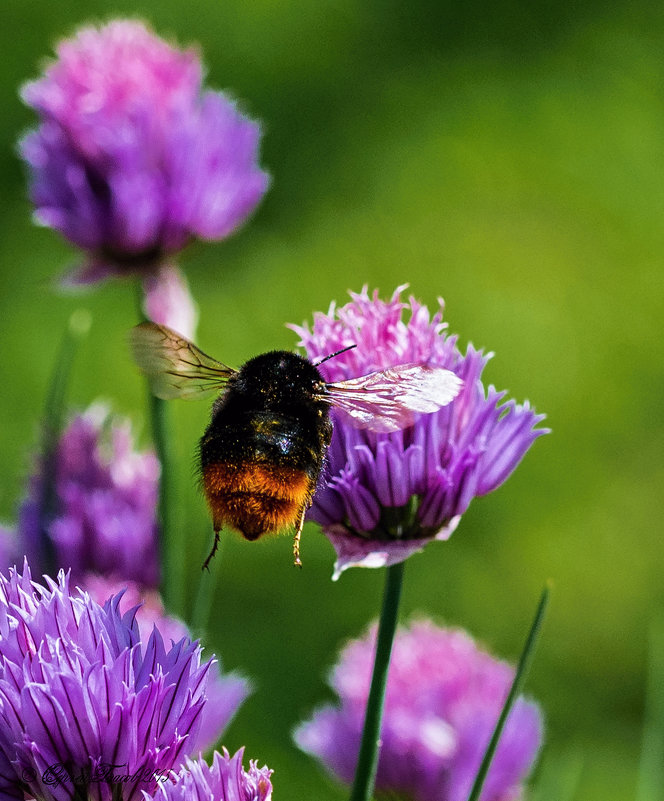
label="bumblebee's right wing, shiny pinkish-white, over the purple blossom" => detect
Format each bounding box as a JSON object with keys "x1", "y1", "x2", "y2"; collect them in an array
[{"x1": 326, "y1": 364, "x2": 463, "y2": 433}]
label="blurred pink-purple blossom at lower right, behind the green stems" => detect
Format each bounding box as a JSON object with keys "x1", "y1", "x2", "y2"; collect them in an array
[{"x1": 295, "y1": 621, "x2": 542, "y2": 801}]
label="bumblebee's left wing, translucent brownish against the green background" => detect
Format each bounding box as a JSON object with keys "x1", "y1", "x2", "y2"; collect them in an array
[{"x1": 131, "y1": 322, "x2": 236, "y2": 400}]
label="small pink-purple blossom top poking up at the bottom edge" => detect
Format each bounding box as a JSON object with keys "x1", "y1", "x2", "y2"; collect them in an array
[{"x1": 144, "y1": 748, "x2": 272, "y2": 801}]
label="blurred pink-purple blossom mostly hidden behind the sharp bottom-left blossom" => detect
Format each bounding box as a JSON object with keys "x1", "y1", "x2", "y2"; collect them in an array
[{"x1": 82, "y1": 575, "x2": 251, "y2": 753}]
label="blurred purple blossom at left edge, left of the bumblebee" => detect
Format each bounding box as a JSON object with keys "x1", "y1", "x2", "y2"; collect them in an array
[{"x1": 12, "y1": 404, "x2": 159, "y2": 587}]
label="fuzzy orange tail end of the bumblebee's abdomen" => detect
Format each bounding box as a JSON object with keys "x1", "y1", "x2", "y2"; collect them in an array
[{"x1": 203, "y1": 462, "x2": 315, "y2": 540}]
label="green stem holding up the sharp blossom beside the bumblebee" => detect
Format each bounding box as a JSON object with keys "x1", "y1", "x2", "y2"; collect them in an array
[{"x1": 350, "y1": 562, "x2": 405, "y2": 801}]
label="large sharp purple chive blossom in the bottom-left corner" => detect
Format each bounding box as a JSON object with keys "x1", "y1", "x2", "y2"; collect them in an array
[{"x1": 0, "y1": 562, "x2": 211, "y2": 801}]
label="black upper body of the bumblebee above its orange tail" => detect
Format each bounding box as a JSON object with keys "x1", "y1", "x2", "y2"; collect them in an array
[{"x1": 200, "y1": 351, "x2": 332, "y2": 482}]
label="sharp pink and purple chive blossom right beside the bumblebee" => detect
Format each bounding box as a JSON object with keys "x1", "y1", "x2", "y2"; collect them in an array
[{"x1": 291, "y1": 287, "x2": 547, "y2": 577}]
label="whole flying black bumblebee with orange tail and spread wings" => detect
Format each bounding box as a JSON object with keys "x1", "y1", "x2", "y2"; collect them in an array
[{"x1": 132, "y1": 322, "x2": 462, "y2": 569}]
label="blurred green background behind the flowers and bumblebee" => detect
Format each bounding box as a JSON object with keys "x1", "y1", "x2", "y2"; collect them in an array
[{"x1": 0, "y1": 0, "x2": 664, "y2": 801}]
